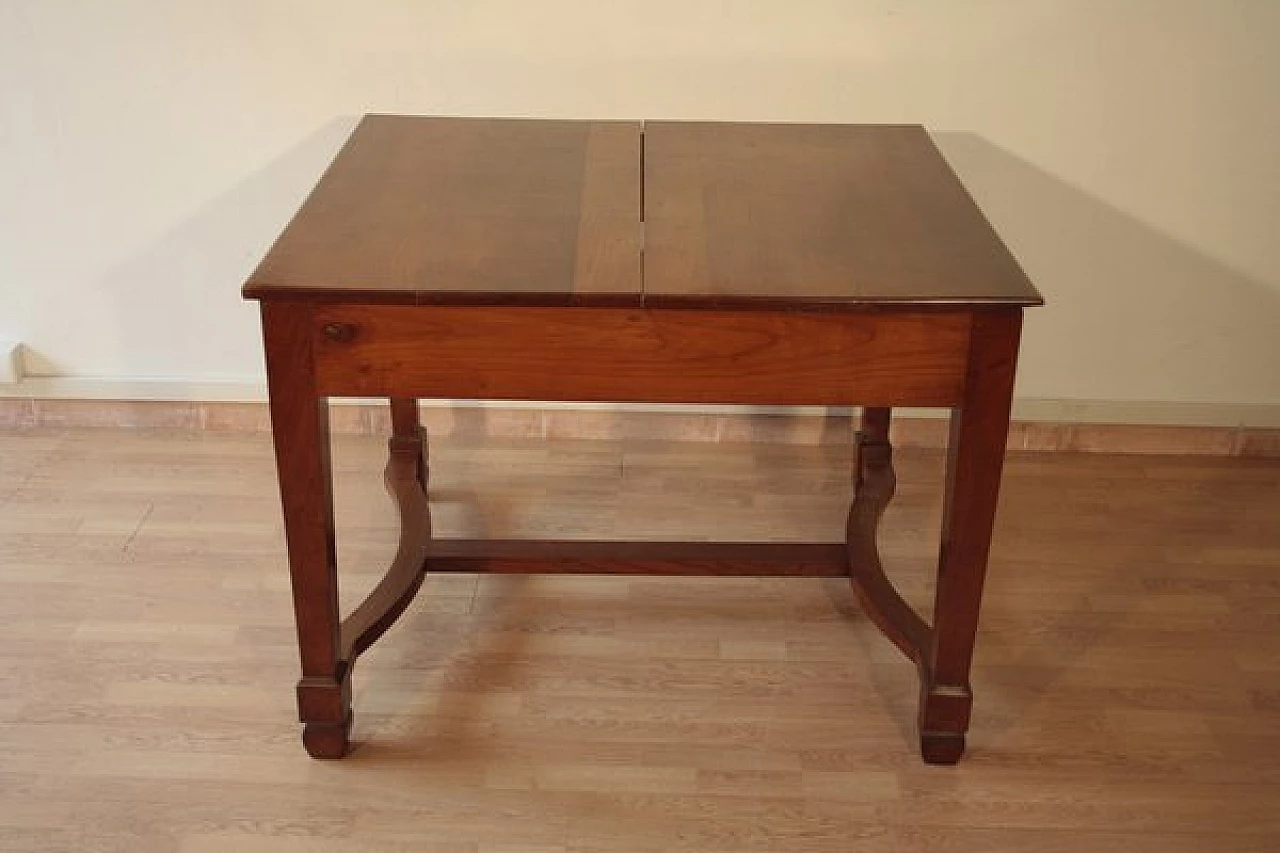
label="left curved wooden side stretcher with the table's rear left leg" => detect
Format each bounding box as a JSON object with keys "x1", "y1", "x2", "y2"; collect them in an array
[{"x1": 339, "y1": 424, "x2": 431, "y2": 666}]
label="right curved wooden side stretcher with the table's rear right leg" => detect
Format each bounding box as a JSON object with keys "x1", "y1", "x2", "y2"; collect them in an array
[{"x1": 846, "y1": 409, "x2": 933, "y2": 666}]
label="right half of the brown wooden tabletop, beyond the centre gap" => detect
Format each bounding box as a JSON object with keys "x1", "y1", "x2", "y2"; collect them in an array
[{"x1": 644, "y1": 122, "x2": 1041, "y2": 309}]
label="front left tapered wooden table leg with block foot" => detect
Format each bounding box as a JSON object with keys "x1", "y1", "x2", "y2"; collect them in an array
[{"x1": 262, "y1": 302, "x2": 351, "y2": 758}]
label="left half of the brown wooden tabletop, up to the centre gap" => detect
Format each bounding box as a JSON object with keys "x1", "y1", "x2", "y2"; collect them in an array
[{"x1": 244, "y1": 115, "x2": 640, "y2": 305}]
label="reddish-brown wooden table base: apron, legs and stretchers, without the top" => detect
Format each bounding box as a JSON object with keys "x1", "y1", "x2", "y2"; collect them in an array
[{"x1": 262, "y1": 307, "x2": 1021, "y2": 763}]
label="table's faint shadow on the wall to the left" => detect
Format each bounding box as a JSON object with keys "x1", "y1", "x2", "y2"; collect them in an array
[{"x1": 97, "y1": 117, "x2": 358, "y2": 380}]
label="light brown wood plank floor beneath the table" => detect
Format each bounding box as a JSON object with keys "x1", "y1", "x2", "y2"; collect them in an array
[{"x1": 0, "y1": 430, "x2": 1280, "y2": 853}]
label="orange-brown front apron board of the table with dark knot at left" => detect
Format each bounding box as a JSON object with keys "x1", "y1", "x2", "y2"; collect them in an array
[{"x1": 306, "y1": 304, "x2": 973, "y2": 407}]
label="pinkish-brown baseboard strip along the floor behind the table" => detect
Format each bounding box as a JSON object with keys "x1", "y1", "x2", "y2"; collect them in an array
[{"x1": 0, "y1": 398, "x2": 1280, "y2": 459}]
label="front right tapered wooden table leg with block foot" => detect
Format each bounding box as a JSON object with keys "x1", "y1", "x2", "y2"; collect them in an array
[{"x1": 919, "y1": 310, "x2": 1021, "y2": 765}]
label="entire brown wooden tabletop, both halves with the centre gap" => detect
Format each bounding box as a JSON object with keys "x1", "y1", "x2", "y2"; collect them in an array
[{"x1": 244, "y1": 115, "x2": 1042, "y2": 310}]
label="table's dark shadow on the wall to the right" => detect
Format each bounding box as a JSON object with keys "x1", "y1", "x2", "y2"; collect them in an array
[{"x1": 934, "y1": 133, "x2": 1280, "y2": 403}]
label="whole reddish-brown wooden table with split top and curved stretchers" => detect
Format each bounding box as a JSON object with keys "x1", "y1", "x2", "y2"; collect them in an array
[{"x1": 244, "y1": 115, "x2": 1041, "y2": 763}]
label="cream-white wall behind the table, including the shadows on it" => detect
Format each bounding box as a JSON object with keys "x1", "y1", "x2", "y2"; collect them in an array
[{"x1": 0, "y1": 0, "x2": 1280, "y2": 411}]
